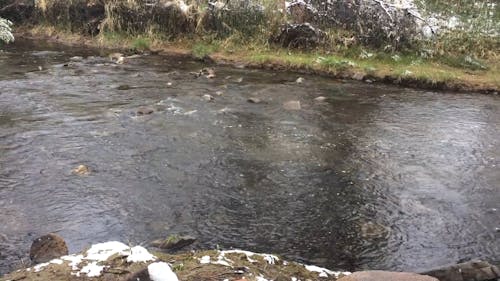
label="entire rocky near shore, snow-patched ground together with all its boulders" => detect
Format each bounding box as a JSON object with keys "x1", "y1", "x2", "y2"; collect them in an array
[{"x1": 0, "y1": 234, "x2": 500, "y2": 281}]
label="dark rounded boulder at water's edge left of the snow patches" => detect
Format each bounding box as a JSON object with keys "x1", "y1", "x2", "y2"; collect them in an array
[{"x1": 30, "y1": 233, "x2": 68, "y2": 263}]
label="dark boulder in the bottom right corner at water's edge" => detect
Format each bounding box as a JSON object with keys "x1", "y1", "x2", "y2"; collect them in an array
[{"x1": 422, "y1": 260, "x2": 500, "y2": 281}]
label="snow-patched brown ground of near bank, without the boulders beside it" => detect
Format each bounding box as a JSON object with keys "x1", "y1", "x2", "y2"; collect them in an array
[{"x1": 0, "y1": 238, "x2": 350, "y2": 281}]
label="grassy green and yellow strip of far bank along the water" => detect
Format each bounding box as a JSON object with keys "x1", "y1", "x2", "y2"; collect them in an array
[{"x1": 16, "y1": 25, "x2": 500, "y2": 94}]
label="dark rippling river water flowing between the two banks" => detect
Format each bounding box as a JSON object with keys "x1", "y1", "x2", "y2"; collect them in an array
[{"x1": 0, "y1": 38, "x2": 500, "y2": 273}]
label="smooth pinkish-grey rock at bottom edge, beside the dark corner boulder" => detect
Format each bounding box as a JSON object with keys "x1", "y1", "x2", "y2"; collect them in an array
[{"x1": 337, "y1": 270, "x2": 439, "y2": 281}]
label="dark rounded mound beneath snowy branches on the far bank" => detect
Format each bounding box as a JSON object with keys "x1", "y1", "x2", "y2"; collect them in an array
[{"x1": 270, "y1": 23, "x2": 325, "y2": 49}]
